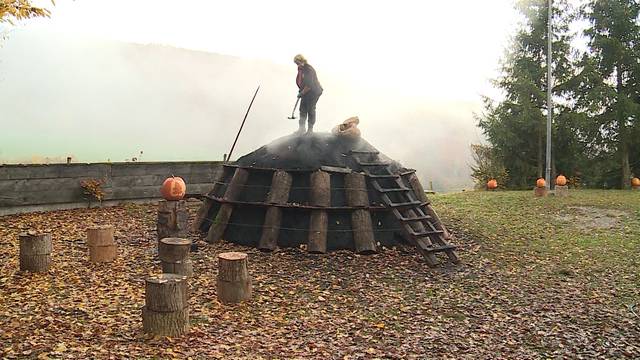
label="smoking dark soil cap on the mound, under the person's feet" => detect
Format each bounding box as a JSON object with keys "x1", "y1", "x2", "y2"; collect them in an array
[{"x1": 237, "y1": 133, "x2": 402, "y2": 172}]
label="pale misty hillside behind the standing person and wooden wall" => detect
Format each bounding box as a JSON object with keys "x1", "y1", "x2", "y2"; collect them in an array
[{"x1": 0, "y1": 30, "x2": 481, "y2": 190}]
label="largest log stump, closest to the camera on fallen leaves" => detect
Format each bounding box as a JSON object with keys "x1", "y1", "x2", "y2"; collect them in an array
[{"x1": 142, "y1": 274, "x2": 189, "y2": 336}]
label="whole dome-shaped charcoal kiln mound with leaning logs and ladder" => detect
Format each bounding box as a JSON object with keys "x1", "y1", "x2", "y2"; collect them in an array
[{"x1": 194, "y1": 133, "x2": 458, "y2": 266}]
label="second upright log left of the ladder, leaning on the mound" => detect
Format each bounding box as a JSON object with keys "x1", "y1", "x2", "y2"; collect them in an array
[{"x1": 307, "y1": 170, "x2": 331, "y2": 253}]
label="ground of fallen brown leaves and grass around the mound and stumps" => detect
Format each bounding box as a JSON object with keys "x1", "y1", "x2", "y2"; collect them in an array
[{"x1": 0, "y1": 191, "x2": 640, "y2": 359}]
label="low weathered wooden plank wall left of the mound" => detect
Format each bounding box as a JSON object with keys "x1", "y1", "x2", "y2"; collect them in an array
[{"x1": 0, "y1": 161, "x2": 221, "y2": 216}]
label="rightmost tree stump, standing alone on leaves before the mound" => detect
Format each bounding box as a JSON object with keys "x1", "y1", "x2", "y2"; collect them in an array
[{"x1": 217, "y1": 252, "x2": 251, "y2": 304}]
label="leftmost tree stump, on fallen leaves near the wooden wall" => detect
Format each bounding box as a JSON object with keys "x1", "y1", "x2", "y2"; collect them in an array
[{"x1": 18, "y1": 232, "x2": 53, "y2": 272}]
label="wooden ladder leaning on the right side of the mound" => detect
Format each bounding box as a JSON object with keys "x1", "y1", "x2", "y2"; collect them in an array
[{"x1": 351, "y1": 150, "x2": 459, "y2": 266}]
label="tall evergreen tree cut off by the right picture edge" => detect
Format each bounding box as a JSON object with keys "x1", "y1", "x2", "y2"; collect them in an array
[{"x1": 576, "y1": 0, "x2": 640, "y2": 188}]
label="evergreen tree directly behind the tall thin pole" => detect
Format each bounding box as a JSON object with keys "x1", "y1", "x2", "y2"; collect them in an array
[{"x1": 476, "y1": 0, "x2": 580, "y2": 188}]
